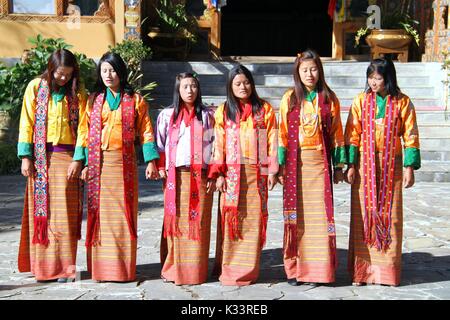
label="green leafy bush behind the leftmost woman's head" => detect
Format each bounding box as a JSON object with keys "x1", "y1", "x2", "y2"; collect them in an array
[{"x1": 0, "y1": 35, "x2": 95, "y2": 120}]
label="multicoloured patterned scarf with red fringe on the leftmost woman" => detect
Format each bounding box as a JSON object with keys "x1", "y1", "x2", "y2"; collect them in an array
[{"x1": 33, "y1": 79, "x2": 78, "y2": 246}]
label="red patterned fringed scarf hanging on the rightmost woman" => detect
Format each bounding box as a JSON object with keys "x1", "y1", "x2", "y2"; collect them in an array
[{"x1": 361, "y1": 92, "x2": 398, "y2": 251}]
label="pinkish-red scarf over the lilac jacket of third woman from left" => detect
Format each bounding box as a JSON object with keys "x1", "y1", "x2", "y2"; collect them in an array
[{"x1": 164, "y1": 108, "x2": 203, "y2": 240}]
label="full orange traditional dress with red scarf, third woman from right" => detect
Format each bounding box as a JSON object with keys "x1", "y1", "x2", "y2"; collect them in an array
[{"x1": 209, "y1": 101, "x2": 278, "y2": 286}]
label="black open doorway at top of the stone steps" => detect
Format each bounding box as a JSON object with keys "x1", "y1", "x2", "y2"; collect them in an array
[{"x1": 221, "y1": 0, "x2": 333, "y2": 57}]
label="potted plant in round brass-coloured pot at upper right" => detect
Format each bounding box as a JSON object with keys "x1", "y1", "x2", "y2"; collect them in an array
[{"x1": 355, "y1": 1, "x2": 420, "y2": 60}]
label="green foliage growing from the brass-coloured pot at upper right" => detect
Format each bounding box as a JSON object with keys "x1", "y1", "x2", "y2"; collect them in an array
[{"x1": 355, "y1": 0, "x2": 420, "y2": 47}]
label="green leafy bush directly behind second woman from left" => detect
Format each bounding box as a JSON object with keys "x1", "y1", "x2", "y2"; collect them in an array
[{"x1": 109, "y1": 39, "x2": 157, "y2": 100}]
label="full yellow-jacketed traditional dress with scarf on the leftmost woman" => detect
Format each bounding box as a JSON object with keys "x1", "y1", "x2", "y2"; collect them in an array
[{"x1": 18, "y1": 78, "x2": 86, "y2": 280}]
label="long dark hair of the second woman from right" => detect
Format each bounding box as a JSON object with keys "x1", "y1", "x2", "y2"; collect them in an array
[{"x1": 289, "y1": 49, "x2": 337, "y2": 110}]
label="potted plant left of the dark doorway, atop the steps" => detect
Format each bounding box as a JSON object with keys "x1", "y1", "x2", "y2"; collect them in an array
[{"x1": 148, "y1": 0, "x2": 198, "y2": 58}]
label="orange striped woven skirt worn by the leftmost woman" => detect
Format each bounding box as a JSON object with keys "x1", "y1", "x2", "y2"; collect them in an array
[{"x1": 18, "y1": 152, "x2": 82, "y2": 280}]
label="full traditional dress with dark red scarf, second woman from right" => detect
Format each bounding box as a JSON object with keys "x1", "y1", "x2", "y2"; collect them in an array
[{"x1": 278, "y1": 89, "x2": 346, "y2": 283}]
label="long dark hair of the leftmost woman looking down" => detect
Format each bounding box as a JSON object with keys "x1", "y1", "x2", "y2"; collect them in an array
[{"x1": 40, "y1": 49, "x2": 80, "y2": 97}]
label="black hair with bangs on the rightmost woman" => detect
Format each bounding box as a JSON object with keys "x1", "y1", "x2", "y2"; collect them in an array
[{"x1": 366, "y1": 58, "x2": 401, "y2": 98}]
